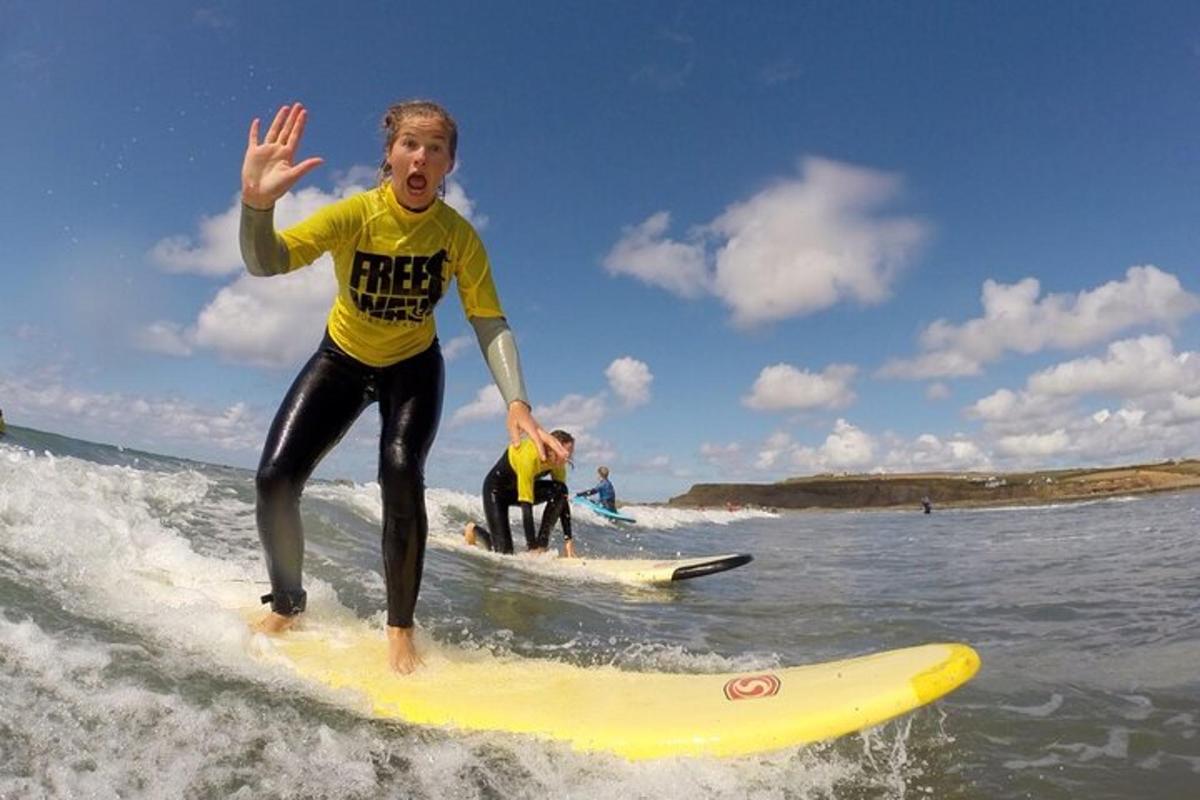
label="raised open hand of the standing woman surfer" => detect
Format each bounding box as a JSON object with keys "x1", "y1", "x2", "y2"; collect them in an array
[{"x1": 241, "y1": 103, "x2": 325, "y2": 209}]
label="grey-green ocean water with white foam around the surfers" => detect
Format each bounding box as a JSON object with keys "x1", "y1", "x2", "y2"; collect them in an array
[{"x1": 0, "y1": 427, "x2": 1200, "y2": 800}]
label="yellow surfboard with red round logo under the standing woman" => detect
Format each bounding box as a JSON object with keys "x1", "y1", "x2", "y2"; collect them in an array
[{"x1": 260, "y1": 624, "x2": 979, "y2": 759}]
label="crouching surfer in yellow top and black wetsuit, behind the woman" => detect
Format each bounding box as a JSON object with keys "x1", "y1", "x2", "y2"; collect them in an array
[{"x1": 462, "y1": 431, "x2": 575, "y2": 558}]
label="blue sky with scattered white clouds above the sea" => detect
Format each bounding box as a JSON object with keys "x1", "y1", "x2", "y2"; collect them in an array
[{"x1": 0, "y1": 0, "x2": 1200, "y2": 500}]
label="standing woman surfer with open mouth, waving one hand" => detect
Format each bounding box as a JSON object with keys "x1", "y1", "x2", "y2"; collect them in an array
[{"x1": 240, "y1": 101, "x2": 566, "y2": 673}]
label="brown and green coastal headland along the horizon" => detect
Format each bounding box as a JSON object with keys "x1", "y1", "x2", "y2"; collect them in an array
[{"x1": 667, "y1": 458, "x2": 1200, "y2": 509}]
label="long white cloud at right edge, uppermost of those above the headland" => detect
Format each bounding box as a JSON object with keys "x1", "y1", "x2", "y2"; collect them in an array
[{"x1": 880, "y1": 266, "x2": 1200, "y2": 379}]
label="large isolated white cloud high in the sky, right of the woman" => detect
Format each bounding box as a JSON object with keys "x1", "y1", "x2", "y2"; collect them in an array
[{"x1": 604, "y1": 158, "x2": 928, "y2": 325}]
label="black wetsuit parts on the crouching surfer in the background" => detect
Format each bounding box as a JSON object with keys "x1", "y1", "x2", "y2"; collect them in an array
[{"x1": 475, "y1": 443, "x2": 571, "y2": 553}]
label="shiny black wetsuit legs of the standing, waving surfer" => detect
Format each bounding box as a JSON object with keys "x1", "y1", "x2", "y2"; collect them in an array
[{"x1": 256, "y1": 332, "x2": 445, "y2": 627}]
